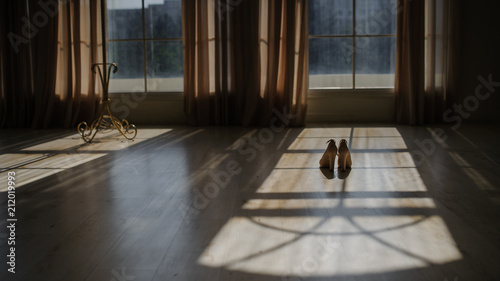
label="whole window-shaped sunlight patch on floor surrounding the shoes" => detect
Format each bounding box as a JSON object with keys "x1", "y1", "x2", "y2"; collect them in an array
[{"x1": 198, "y1": 128, "x2": 462, "y2": 278}]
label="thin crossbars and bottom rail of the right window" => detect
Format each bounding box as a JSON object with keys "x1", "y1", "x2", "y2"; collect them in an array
[{"x1": 308, "y1": 0, "x2": 397, "y2": 91}]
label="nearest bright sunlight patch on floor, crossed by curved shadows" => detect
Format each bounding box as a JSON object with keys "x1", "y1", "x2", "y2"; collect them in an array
[{"x1": 198, "y1": 214, "x2": 462, "y2": 276}]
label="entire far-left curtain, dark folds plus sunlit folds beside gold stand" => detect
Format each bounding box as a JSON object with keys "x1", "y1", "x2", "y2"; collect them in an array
[{"x1": 0, "y1": 0, "x2": 101, "y2": 128}]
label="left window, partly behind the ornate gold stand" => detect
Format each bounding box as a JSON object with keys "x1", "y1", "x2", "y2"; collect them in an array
[{"x1": 107, "y1": 0, "x2": 184, "y2": 92}]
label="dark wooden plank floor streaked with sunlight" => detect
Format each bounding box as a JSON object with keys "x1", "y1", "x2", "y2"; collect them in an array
[{"x1": 0, "y1": 124, "x2": 500, "y2": 281}]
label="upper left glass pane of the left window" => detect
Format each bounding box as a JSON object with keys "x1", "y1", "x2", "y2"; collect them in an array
[{"x1": 107, "y1": 0, "x2": 142, "y2": 39}]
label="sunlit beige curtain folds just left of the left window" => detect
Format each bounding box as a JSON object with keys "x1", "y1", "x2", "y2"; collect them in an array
[{"x1": 54, "y1": 0, "x2": 102, "y2": 127}]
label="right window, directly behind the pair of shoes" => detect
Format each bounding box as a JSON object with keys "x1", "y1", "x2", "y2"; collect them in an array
[{"x1": 309, "y1": 0, "x2": 397, "y2": 89}]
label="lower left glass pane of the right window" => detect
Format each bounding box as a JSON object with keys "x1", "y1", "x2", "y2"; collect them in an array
[{"x1": 309, "y1": 38, "x2": 352, "y2": 88}]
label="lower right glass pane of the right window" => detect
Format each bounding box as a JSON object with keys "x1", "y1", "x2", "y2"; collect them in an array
[{"x1": 356, "y1": 37, "x2": 396, "y2": 88}]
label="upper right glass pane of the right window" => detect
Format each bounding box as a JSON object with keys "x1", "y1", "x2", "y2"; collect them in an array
[{"x1": 355, "y1": 0, "x2": 397, "y2": 35}]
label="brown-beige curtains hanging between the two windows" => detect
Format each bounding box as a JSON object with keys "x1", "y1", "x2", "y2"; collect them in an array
[{"x1": 182, "y1": 0, "x2": 308, "y2": 126}]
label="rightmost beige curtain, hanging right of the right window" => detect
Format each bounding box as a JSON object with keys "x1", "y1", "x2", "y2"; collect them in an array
[{"x1": 395, "y1": 0, "x2": 460, "y2": 125}]
